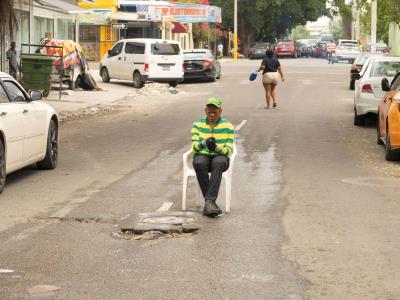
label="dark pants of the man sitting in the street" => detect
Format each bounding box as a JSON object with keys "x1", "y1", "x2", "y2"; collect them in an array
[{"x1": 193, "y1": 154, "x2": 229, "y2": 201}]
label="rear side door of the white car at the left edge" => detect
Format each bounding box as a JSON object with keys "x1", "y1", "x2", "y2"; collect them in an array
[{"x1": 0, "y1": 82, "x2": 24, "y2": 172}]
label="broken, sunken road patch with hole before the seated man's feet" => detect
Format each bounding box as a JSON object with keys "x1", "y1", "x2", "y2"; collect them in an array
[{"x1": 113, "y1": 212, "x2": 201, "y2": 240}]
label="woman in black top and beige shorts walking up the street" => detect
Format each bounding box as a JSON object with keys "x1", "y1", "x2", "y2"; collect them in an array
[{"x1": 258, "y1": 49, "x2": 285, "y2": 109}]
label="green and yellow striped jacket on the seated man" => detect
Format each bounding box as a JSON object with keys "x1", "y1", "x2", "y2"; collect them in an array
[{"x1": 192, "y1": 117, "x2": 235, "y2": 156}]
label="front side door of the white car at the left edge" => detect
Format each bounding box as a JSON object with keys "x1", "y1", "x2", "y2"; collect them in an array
[{"x1": 4, "y1": 81, "x2": 47, "y2": 162}]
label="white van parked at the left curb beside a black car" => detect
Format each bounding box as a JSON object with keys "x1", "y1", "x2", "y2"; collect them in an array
[{"x1": 99, "y1": 39, "x2": 183, "y2": 88}]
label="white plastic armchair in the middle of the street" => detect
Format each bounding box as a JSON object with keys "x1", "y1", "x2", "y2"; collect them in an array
[{"x1": 182, "y1": 144, "x2": 237, "y2": 213}]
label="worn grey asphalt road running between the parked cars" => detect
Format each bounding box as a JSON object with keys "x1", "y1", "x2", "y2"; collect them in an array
[{"x1": 0, "y1": 59, "x2": 400, "y2": 300}]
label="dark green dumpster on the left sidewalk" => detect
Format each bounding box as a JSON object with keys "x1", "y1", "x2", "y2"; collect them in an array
[{"x1": 21, "y1": 54, "x2": 54, "y2": 90}]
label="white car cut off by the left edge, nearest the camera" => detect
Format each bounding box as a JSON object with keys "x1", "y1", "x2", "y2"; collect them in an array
[{"x1": 0, "y1": 72, "x2": 58, "y2": 192}]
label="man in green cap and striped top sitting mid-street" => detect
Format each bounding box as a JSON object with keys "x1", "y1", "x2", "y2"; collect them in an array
[{"x1": 192, "y1": 98, "x2": 234, "y2": 217}]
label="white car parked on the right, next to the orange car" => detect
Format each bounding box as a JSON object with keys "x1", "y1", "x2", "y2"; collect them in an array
[{"x1": 354, "y1": 56, "x2": 400, "y2": 126}]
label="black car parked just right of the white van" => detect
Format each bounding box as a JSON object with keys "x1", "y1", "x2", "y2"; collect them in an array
[{"x1": 183, "y1": 49, "x2": 221, "y2": 81}]
